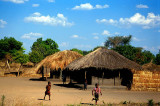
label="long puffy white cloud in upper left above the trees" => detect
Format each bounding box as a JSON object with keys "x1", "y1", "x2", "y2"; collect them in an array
[{"x1": 24, "y1": 12, "x2": 73, "y2": 26}]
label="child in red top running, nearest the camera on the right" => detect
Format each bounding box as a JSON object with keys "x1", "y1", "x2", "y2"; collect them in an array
[{"x1": 92, "y1": 83, "x2": 102, "y2": 105}]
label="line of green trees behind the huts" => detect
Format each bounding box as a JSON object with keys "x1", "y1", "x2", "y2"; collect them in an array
[{"x1": 0, "y1": 35, "x2": 160, "y2": 67}]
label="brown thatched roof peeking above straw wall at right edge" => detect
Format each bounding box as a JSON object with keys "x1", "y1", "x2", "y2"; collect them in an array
[{"x1": 142, "y1": 62, "x2": 160, "y2": 71}]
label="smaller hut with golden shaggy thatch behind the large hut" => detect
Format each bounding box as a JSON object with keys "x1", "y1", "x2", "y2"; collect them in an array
[{"x1": 35, "y1": 50, "x2": 82, "y2": 78}]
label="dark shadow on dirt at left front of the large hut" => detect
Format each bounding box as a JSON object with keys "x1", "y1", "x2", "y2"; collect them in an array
[{"x1": 54, "y1": 83, "x2": 83, "y2": 90}]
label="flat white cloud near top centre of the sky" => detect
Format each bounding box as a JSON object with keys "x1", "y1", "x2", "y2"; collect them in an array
[{"x1": 72, "y1": 3, "x2": 109, "y2": 10}]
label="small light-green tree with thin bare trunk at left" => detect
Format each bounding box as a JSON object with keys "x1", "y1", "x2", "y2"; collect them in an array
[{"x1": 12, "y1": 51, "x2": 29, "y2": 76}]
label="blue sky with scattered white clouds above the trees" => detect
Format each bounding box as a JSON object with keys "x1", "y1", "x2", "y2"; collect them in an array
[{"x1": 0, "y1": 0, "x2": 160, "y2": 54}]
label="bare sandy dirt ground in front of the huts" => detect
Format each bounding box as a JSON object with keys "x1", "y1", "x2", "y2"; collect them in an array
[{"x1": 0, "y1": 77, "x2": 160, "y2": 106}]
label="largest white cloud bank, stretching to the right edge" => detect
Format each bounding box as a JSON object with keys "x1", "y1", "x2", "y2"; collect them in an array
[{"x1": 96, "y1": 13, "x2": 160, "y2": 29}]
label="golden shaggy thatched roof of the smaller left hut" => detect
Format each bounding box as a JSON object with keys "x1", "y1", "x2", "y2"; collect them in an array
[{"x1": 36, "y1": 50, "x2": 82, "y2": 71}]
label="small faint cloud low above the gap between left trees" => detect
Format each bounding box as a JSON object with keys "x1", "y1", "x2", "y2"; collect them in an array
[{"x1": 21, "y1": 32, "x2": 43, "y2": 40}]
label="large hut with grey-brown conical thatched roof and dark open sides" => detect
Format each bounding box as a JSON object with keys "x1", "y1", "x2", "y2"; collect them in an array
[{"x1": 66, "y1": 47, "x2": 141, "y2": 85}]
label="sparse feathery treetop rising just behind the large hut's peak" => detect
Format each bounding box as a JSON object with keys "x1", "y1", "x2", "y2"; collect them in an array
[{"x1": 104, "y1": 35, "x2": 132, "y2": 48}]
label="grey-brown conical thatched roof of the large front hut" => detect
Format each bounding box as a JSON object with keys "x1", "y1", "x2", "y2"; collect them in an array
[{"x1": 66, "y1": 47, "x2": 141, "y2": 70}]
